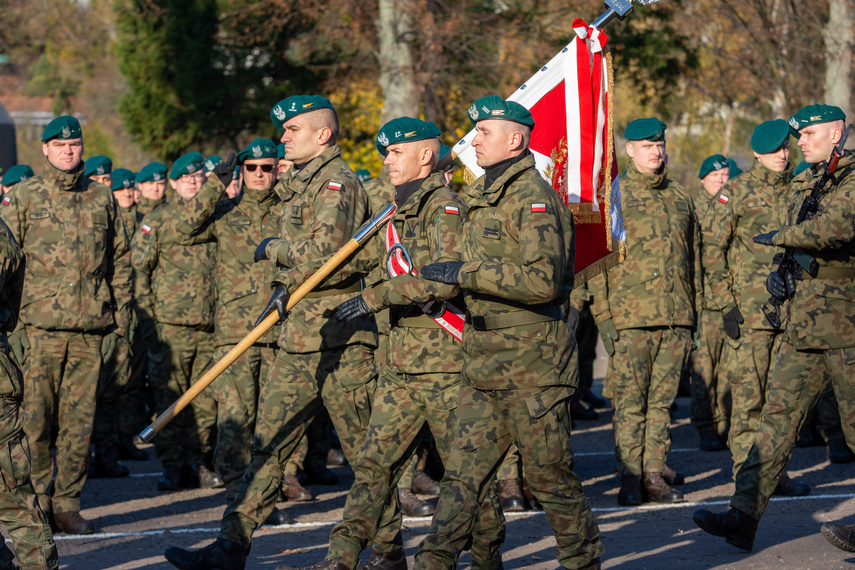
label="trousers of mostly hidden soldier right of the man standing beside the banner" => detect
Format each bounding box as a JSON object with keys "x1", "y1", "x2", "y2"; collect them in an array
[{"x1": 691, "y1": 311, "x2": 731, "y2": 437}]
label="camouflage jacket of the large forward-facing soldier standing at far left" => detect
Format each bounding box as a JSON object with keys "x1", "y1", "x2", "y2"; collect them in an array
[{"x1": 0, "y1": 156, "x2": 134, "y2": 335}]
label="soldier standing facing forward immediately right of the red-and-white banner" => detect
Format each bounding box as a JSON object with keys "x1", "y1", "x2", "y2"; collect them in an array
[{"x1": 588, "y1": 117, "x2": 701, "y2": 505}]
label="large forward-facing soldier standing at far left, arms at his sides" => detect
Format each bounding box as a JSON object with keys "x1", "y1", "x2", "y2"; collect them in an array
[{"x1": 2, "y1": 116, "x2": 133, "y2": 534}]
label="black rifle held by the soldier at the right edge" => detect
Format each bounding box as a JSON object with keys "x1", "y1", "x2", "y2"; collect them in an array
[{"x1": 763, "y1": 127, "x2": 849, "y2": 329}]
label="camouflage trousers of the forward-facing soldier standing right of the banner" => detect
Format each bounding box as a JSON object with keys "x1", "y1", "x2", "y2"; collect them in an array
[{"x1": 606, "y1": 327, "x2": 692, "y2": 476}]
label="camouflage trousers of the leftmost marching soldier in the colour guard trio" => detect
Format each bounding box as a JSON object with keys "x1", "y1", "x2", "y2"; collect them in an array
[{"x1": 220, "y1": 344, "x2": 384, "y2": 550}]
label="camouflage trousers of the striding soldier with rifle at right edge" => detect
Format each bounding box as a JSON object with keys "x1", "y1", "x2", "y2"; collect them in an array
[{"x1": 730, "y1": 342, "x2": 855, "y2": 520}]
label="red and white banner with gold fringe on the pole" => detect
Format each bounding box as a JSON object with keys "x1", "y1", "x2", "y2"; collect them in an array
[{"x1": 454, "y1": 18, "x2": 626, "y2": 281}]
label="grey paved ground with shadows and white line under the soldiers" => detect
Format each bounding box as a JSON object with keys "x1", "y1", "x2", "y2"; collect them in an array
[{"x1": 10, "y1": 348, "x2": 855, "y2": 570}]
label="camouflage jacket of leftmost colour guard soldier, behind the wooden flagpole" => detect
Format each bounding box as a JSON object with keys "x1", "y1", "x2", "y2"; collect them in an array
[{"x1": 267, "y1": 145, "x2": 377, "y2": 356}]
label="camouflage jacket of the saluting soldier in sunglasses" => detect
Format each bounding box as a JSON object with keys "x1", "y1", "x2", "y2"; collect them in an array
[{"x1": 174, "y1": 176, "x2": 282, "y2": 346}]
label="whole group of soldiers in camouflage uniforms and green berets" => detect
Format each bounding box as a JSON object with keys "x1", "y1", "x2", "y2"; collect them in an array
[{"x1": 0, "y1": 95, "x2": 855, "y2": 570}]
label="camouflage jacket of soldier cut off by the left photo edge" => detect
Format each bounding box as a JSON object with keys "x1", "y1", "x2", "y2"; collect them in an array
[{"x1": 0, "y1": 219, "x2": 24, "y2": 400}]
